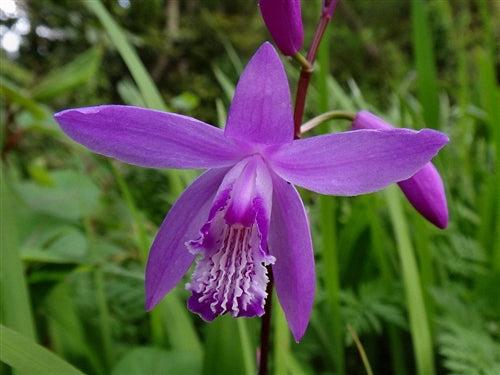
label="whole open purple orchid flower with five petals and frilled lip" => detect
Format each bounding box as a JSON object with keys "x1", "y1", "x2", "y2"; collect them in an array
[{"x1": 55, "y1": 43, "x2": 448, "y2": 341}]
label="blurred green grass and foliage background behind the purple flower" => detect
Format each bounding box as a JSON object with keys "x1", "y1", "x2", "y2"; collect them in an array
[{"x1": 0, "y1": 0, "x2": 500, "y2": 375}]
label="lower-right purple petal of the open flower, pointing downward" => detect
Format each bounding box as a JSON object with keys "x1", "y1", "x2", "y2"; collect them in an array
[{"x1": 268, "y1": 175, "x2": 316, "y2": 342}]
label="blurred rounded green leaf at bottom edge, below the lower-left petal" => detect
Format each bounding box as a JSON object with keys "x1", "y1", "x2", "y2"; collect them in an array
[{"x1": 111, "y1": 347, "x2": 201, "y2": 375}]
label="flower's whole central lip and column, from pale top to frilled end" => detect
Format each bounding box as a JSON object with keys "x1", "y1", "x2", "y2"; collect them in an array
[{"x1": 186, "y1": 158, "x2": 275, "y2": 321}]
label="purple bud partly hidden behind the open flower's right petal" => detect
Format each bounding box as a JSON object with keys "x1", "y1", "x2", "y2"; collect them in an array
[{"x1": 351, "y1": 111, "x2": 448, "y2": 229}]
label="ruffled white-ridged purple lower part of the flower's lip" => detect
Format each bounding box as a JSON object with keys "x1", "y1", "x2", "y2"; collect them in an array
[{"x1": 186, "y1": 207, "x2": 274, "y2": 321}]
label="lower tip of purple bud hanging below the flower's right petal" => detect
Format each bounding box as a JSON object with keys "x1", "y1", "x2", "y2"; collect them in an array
[{"x1": 398, "y1": 163, "x2": 448, "y2": 229}]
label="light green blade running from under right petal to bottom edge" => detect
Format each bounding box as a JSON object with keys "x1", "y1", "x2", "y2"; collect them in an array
[{"x1": 385, "y1": 185, "x2": 436, "y2": 375}]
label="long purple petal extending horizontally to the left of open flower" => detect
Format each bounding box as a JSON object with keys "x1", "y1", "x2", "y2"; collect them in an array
[{"x1": 54, "y1": 105, "x2": 240, "y2": 169}]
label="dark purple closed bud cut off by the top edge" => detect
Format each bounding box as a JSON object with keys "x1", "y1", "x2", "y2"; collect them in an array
[{"x1": 259, "y1": 0, "x2": 304, "y2": 56}]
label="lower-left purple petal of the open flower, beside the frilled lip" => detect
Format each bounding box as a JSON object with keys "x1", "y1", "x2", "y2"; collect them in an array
[{"x1": 146, "y1": 168, "x2": 227, "y2": 310}]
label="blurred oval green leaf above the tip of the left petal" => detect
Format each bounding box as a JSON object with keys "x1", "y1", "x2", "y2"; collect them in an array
[{"x1": 33, "y1": 47, "x2": 102, "y2": 100}]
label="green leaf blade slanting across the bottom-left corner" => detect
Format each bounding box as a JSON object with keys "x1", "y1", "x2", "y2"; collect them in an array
[{"x1": 0, "y1": 325, "x2": 83, "y2": 375}]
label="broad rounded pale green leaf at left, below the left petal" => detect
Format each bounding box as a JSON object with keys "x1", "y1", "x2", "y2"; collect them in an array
[{"x1": 16, "y1": 170, "x2": 100, "y2": 220}]
